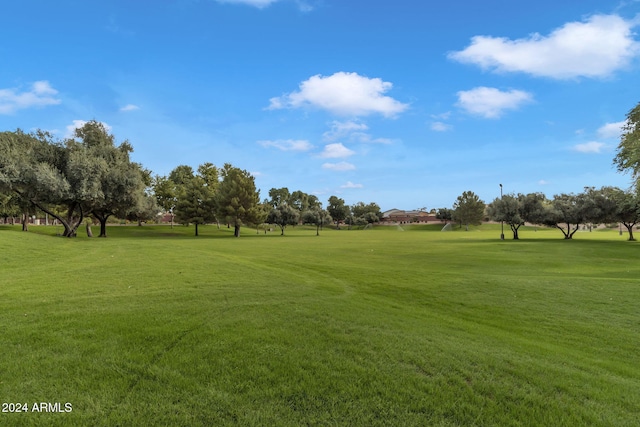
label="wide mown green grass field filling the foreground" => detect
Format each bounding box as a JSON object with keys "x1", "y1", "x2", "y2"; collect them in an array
[{"x1": 0, "y1": 225, "x2": 640, "y2": 426}]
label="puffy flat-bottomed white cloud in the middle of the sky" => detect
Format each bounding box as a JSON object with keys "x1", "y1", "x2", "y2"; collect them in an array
[{"x1": 268, "y1": 71, "x2": 408, "y2": 117}]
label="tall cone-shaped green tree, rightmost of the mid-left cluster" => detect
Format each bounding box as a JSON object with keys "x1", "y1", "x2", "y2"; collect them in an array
[{"x1": 216, "y1": 163, "x2": 264, "y2": 237}]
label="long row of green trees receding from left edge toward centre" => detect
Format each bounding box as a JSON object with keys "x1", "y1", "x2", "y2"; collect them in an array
[{"x1": 0, "y1": 120, "x2": 381, "y2": 237}]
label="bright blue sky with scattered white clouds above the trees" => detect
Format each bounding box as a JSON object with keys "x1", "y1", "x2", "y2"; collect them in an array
[{"x1": 0, "y1": 0, "x2": 640, "y2": 210}]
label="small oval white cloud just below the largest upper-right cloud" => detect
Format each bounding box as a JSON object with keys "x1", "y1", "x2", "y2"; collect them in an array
[{"x1": 458, "y1": 87, "x2": 533, "y2": 119}]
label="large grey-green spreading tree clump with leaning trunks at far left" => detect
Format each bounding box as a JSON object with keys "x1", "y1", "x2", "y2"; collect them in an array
[{"x1": 0, "y1": 121, "x2": 144, "y2": 237}]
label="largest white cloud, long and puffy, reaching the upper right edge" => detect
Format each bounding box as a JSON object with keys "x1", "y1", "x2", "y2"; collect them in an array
[{"x1": 449, "y1": 15, "x2": 640, "y2": 79}]
